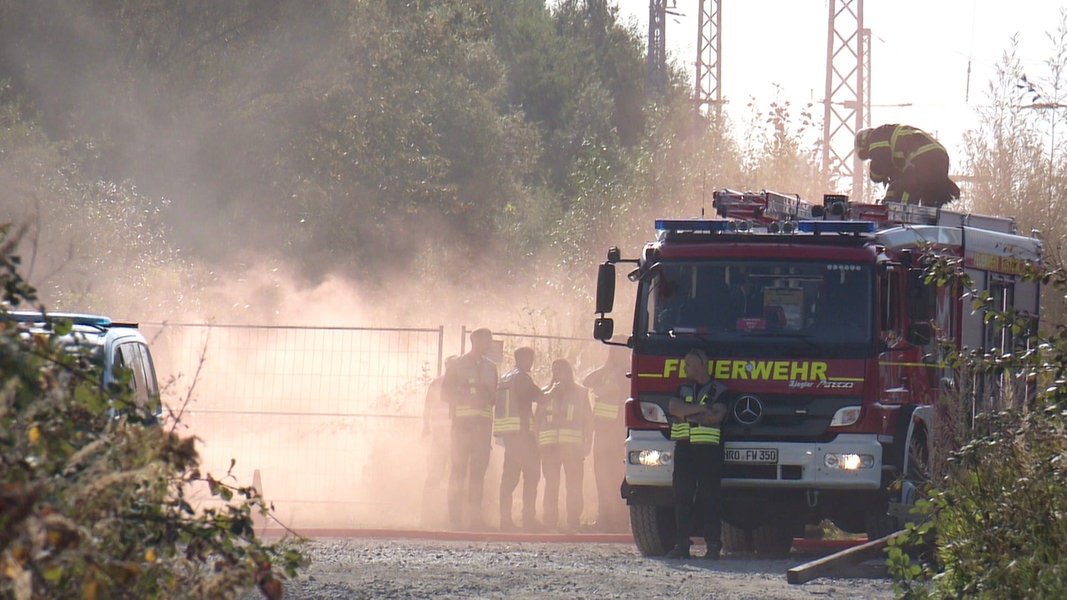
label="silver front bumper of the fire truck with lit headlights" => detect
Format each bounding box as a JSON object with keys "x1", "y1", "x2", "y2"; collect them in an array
[{"x1": 626, "y1": 430, "x2": 882, "y2": 490}]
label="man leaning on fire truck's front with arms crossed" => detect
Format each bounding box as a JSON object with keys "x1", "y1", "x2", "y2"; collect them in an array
[{"x1": 667, "y1": 348, "x2": 727, "y2": 559}]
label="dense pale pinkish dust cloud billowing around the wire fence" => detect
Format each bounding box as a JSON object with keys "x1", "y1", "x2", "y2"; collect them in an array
[{"x1": 143, "y1": 254, "x2": 623, "y2": 530}]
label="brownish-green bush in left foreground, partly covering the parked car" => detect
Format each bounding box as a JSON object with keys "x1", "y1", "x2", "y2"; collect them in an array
[{"x1": 0, "y1": 226, "x2": 302, "y2": 599}]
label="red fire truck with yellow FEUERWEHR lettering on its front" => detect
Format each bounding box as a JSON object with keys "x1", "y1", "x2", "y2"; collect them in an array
[{"x1": 594, "y1": 190, "x2": 1041, "y2": 555}]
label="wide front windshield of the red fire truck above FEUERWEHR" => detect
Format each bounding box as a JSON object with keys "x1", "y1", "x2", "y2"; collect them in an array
[{"x1": 636, "y1": 258, "x2": 874, "y2": 349}]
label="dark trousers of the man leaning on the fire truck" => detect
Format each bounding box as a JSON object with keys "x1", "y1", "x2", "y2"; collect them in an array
[{"x1": 672, "y1": 441, "x2": 722, "y2": 549}]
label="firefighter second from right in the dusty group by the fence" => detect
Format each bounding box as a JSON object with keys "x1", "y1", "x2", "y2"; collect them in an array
[{"x1": 536, "y1": 359, "x2": 592, "y2": 532}]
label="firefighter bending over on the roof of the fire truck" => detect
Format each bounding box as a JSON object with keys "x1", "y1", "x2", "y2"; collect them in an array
[{"x1": 856, "y1": 124, "x2": 959, "y2": 206}]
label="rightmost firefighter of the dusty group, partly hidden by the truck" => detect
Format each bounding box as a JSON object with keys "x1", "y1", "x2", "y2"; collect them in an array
[{"x1": 582, "y1": 346, "x2": 630, "y2": 531}]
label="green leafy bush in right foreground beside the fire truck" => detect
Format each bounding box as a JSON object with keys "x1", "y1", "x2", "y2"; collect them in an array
[{"x1": 888, "y1": 250, "x2": 1067, "y2": 598}]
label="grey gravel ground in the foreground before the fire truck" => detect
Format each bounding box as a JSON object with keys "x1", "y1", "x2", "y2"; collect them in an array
[{"x1": 273, "y1": 538, "x2": 894, "y2": 600}]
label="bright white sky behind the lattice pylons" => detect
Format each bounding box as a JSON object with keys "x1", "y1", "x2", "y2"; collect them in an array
[{"x1": 612, "y1": 0, "x2": 1067, "y2": 156}]
